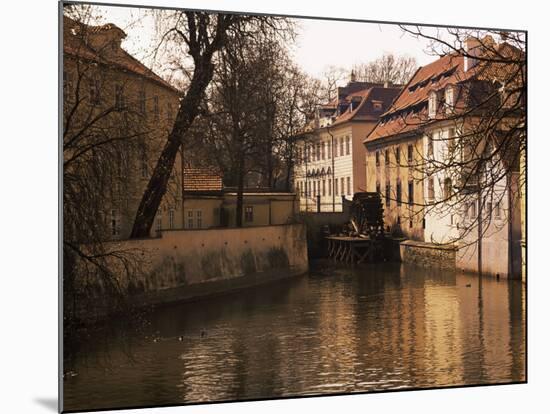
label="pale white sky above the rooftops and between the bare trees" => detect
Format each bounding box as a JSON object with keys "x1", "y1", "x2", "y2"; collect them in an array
[{"x1": 85, "y1": 6, "x2": 440, "y2": 82}]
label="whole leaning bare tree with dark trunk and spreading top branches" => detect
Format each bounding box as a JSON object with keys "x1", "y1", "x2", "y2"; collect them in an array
[{"x1": 131, "y1": 11, "x2": 294, "y2": 238}]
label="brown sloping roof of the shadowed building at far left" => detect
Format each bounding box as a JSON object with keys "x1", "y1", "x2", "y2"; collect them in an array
[{"x1": 63, "y1": 16, "x2": 181, "y2": 94}]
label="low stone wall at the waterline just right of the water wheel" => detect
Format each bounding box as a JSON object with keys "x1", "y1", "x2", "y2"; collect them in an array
[{"x1": 399, "y1": 240, "x2": 456, "y2": 269}]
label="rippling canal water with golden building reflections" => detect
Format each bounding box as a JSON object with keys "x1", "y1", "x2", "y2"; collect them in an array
[{"x1": 63, "y1": 262, "x2": 526, "y2": 410}]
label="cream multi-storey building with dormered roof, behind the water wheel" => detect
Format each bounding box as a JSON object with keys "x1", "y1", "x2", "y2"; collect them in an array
[{"x1": 294, "y1": 77, "x2": 399, "y2": 211}]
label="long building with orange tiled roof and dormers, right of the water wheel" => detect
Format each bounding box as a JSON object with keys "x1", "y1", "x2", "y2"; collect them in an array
[{"x1": 365, "y1": 37, "x2": 521, "y2": 276}]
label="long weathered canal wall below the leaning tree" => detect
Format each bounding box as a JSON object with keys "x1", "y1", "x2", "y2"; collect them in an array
[{"x1": 78, "y1": 224, "x2": 308, "y2": 316}]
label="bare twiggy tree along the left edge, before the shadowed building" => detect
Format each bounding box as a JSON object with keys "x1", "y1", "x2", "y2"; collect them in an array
[{"x1": 62, "y1": 7, "x2": 150, "y2": 334}]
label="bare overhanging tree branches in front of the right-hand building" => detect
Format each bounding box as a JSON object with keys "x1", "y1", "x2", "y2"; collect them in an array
[{"x1": 381, "y1": 26, "x2": 527, "y2": 269}]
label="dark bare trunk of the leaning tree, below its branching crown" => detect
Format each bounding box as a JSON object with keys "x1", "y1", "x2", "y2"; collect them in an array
[{"x1": 130, "y1": 59, "x2": 214, "y2": 238}]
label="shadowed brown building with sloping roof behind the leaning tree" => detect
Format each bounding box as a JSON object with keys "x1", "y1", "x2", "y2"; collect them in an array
[{"x1": 63, "y1": 16, "x2": 183, "y2": 239}]
